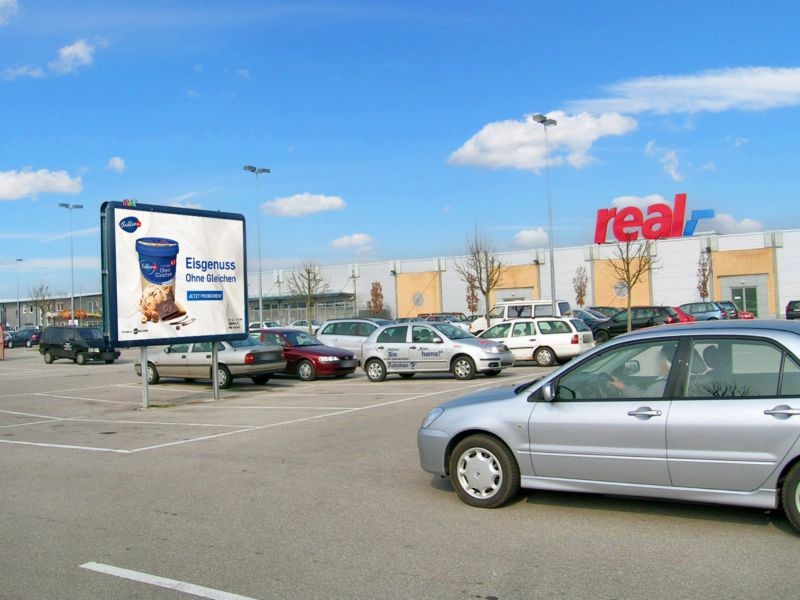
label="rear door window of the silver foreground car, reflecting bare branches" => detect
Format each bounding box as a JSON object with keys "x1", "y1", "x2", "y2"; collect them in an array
[{"x1": 685, "y1": 338, "x2": 792, "y2": 398}]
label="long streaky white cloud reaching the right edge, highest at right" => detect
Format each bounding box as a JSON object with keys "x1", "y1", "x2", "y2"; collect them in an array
[{"x1": 567, "y1": 67, "x2": 800, "y2": 114}]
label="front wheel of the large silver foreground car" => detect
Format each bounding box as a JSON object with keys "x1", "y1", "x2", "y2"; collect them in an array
[{"x1": 450, "y1": 434, "x2": 519, "y2": 508}]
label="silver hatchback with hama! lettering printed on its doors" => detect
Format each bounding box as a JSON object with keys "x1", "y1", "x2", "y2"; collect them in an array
[{"x1": 361, "y1": 322, "x2": 514, "y2": 381}]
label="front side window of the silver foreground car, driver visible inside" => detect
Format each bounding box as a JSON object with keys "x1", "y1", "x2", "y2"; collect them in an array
[{"x1": 556, "y1": 340, "x2": 678, "y2": 401}]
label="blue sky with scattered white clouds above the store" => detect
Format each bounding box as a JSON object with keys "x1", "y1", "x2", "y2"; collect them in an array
[{"x1": 0, "y1": 0, "x2": 800, "y2": 299}]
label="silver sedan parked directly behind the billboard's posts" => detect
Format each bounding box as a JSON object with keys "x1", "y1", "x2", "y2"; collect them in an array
[{"x1": 134, "y1": 337, "x2": 286, "y2": 389}]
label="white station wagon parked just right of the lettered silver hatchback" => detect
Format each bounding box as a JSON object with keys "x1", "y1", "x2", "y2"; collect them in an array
[{"x1": 479, "y1": 317, "x2": 594, "y2": 367}]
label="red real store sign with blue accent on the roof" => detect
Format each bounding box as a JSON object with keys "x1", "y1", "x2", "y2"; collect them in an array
[{"x1": 594, "y1": 194, "x2": 714, "y2": 244}]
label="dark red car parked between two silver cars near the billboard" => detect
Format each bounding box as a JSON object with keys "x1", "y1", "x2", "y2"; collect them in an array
[{"x1": 260, "y1": 327, "x2": 358, "y2": 381}]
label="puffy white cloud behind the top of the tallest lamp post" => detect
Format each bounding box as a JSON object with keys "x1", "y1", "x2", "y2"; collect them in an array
[{"x1": 448, "y1": 111, "x2": 637, "y2": 171}]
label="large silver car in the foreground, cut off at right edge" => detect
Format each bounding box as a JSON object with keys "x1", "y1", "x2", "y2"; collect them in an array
[{"x1": 417, "y1": 321, "x2": 800, "y2": 530}]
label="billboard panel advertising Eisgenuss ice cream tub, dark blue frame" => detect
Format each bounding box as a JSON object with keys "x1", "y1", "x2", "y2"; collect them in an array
[{"x1": 100, "y1": 200, "x2": 248, "y2": 347}]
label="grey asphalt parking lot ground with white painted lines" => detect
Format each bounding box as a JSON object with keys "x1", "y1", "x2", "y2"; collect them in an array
[{"x1": 0, "y1": 348, "x2": 800, "y2": 600}]
